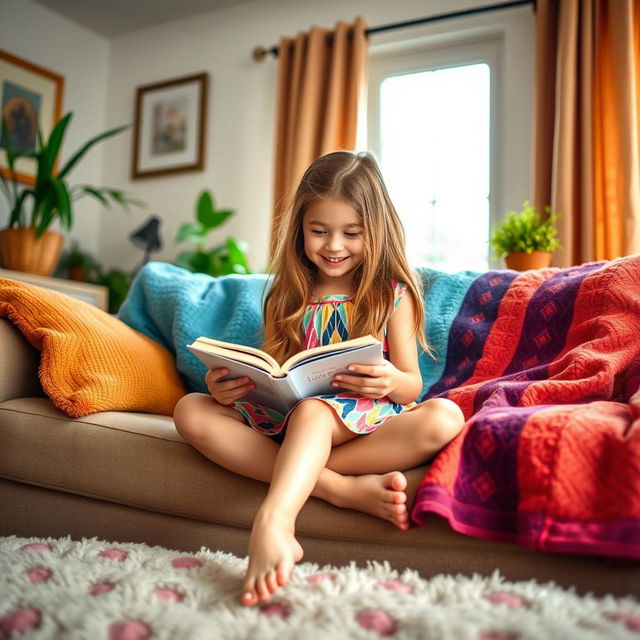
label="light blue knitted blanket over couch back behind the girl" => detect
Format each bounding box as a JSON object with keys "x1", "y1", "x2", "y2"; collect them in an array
[{"x1": 118, "y1": 262, "x2": 478, "y2": 392}]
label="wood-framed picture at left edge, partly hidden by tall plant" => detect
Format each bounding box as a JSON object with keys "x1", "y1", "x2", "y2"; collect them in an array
[{"x1": 0, "y1": 49, "x2": 64, "y2": 184}]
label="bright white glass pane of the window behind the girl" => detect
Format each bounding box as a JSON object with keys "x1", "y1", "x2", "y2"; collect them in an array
[{"x1": 380, "y1": 63, "x2": 490, "y2": 272}]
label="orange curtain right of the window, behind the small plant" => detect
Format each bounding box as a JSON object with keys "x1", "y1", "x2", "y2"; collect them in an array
[{"x1": 534, "y1": 0, "x2": 640, "y2": 266}]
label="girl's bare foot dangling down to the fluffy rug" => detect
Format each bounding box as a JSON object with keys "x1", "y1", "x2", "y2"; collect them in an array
[{"x1": 240, "y1": 512, "x2": 303, "y2": 606}]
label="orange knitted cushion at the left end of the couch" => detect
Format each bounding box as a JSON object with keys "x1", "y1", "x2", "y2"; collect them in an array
[{"x1": 0, "y1": 278, "x2": 184, "y2": 418}]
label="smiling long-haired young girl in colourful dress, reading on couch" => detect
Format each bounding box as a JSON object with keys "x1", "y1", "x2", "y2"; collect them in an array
[{"x1": 174, "y1": 151, "x2": 464, "y2": 605}]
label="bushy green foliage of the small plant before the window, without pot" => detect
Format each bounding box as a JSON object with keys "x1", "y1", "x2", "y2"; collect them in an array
[{"x1": 491, "y1": 201, "x2": 561, "y2": 258}]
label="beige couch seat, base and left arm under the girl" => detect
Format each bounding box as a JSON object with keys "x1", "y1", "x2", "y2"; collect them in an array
[{"x1": 0, "y1": 318, "x2": 640, "y2": 594}]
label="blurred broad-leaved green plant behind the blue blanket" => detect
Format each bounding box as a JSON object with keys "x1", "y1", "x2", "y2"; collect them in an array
[{"x1": 175, "y1": 190, "x2": 251, "y2": 276}]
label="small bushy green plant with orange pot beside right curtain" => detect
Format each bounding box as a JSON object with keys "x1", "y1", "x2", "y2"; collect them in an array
[{"x1": 491, "y1": 201, "x2": 561, "y2": 271}]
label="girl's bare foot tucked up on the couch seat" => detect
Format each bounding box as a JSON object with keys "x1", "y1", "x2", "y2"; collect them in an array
[{"x1": 330, "y1": 471, "x2": 409, "y2": 529}]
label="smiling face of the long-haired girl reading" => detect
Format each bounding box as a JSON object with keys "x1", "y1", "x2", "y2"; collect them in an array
[{"x1": 302, "y1": 200, "x2": 364, "y2": 293}]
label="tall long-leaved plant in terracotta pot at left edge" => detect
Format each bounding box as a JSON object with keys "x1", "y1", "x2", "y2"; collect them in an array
[{"x1": 0, "y1": 113, "x2": 142, "y2": 275}]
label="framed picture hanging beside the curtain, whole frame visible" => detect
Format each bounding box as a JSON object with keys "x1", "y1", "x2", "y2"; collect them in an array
[{"x1": 131, "y1": 73, "x2": 208, "y2": 179}]
